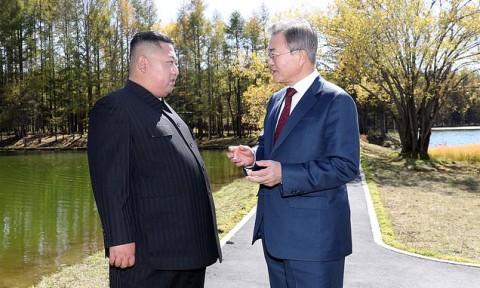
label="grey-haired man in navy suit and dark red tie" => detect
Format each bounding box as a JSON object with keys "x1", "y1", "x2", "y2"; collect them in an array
[{"x1": 227, "y1": 21, "x2": 360, "y2": 288}]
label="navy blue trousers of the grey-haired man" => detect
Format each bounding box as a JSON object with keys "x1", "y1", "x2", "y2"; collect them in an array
[{"x1": 262, "y1": 241, "x2": 345, "y2": 288}]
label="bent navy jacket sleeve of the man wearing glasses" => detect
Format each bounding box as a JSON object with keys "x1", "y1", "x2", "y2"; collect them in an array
[{"x1": 280, "y1": 93, "x2": 360, "y2": 197}]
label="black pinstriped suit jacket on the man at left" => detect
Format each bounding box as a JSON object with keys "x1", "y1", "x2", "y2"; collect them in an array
[{"x1": 88, "y1": 80, "x2": 221, "y2": 270}]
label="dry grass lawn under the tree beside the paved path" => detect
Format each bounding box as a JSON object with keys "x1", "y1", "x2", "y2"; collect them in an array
[{"x1": 362, "y1": 142, "x2": 480, "y2": 263}]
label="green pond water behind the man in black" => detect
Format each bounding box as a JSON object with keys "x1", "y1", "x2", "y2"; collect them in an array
[{"x1": 0, "y1": 151, "x2": 241, "y2": 288}]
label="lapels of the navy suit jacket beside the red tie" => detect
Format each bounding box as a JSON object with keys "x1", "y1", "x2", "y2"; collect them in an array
[{"x1": 269, "y1": 77, "x2": 324, "y2": 153}]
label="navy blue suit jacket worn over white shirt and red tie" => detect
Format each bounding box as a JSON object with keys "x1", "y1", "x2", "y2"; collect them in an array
[{"x1": 253, "y1": 76, "x2": 360, "y2": 261}]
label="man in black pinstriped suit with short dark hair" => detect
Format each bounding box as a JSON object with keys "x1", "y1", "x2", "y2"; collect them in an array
[{"x1": 88, "y1": 31, "x2": 221, "y2": 288}]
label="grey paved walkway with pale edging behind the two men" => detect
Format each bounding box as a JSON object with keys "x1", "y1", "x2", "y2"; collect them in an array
[{"x1": 205, "y1": 173, "x2": 480, "y2": 288}]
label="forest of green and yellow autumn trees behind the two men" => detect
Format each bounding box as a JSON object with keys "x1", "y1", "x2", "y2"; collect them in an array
[{"x1": 0, "y1": 0, "x2": 480, "y2": 158}]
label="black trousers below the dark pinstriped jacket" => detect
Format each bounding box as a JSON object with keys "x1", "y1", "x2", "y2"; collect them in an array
[{"x1": 110, "y1": 266, "x2": 206, "y2": 288}]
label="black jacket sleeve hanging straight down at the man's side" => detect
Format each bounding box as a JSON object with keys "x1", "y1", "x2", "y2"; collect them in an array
[{"x1": 88, "y1": 96, "x2": 134, "y2": 249}]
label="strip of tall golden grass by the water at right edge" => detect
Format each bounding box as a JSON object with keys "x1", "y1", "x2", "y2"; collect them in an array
[{"x1": 429, "y1": 144, "x2": 480, "y2": 162}]
